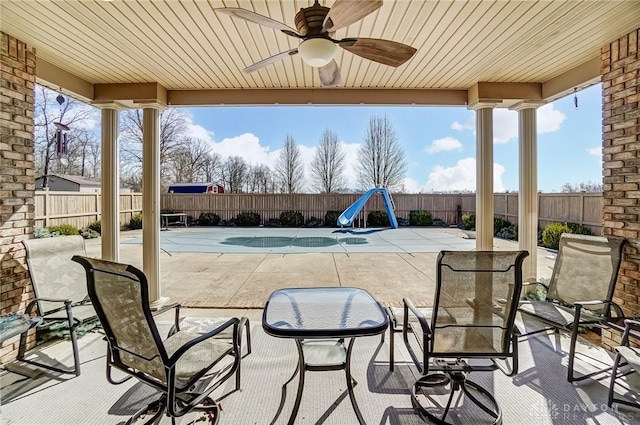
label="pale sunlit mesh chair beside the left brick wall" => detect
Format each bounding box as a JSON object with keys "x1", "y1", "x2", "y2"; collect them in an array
[{"x1": 17, "y1": 236, "x2": 98, "y2": 376}]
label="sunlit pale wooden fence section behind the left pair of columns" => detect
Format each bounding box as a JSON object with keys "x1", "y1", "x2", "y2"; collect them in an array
[{"x1": 35, "y1": 190, "x2": 142, "y2": 229}]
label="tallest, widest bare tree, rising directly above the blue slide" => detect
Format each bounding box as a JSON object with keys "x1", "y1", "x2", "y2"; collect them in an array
[{"x1": 358, "y1": 115, "x2": 407, "y2": 189}]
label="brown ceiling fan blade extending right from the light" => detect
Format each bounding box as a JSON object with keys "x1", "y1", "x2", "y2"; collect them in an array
[{"x1": 338, "y1": 38, "x2": 416, "y2": 66}]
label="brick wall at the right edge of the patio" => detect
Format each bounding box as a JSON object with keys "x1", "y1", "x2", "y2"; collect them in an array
[{"x1": 601, "y1": 28, "x2": 640, "y2": 347}]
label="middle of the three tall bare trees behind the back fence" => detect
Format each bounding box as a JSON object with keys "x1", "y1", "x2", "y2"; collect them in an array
[{"x1": 311, "y1": 130, "x2": 345, "y2": 193}]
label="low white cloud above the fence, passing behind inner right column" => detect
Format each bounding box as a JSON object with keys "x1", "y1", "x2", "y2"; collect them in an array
[{"x1": 422, "y1": 158, "x2": 505, "y2": 192}]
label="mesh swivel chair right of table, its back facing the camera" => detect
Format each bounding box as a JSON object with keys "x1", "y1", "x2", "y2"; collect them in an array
[{"x1": 402, "y1": 251, "x2": 529, "y2": 424}]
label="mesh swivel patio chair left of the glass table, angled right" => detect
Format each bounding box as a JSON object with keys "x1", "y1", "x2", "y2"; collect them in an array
[{"x1": 73, "y1": 256, "x2": 242, "y2": 424}]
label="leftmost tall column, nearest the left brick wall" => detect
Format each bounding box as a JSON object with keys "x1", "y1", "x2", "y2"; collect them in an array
[{"x1": 100, "y1": 108, "x2": 120, "y2": 262}]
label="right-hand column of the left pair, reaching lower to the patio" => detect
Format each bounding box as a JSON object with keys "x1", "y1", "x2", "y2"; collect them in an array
[{"x1": 142, "y1": 105, "x2": 168, "y2": 307}]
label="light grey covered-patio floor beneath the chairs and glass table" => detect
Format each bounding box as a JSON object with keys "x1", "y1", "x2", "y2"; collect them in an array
[{"x1": 0, "y1": 309, "x2": 640, "y2": 425}]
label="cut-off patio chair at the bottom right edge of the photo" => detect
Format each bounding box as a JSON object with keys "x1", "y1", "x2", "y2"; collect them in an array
[{"x1": 607, "y1": 319, "x2": 640, "y2": 409}]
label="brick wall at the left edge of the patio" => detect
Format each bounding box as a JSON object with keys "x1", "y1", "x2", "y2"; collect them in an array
[{"x1": 0, "y1": 33, "x2": 36, "y2": 363}]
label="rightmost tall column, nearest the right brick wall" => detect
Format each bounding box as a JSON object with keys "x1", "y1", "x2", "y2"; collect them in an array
[{"x1": 512, "y1": 102, "x2": 539, "y2": 282}]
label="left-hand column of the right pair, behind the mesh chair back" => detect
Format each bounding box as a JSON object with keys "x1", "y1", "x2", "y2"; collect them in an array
[{"x1": 473, "y1": 104, "x2": 495, "y2": 251}]
